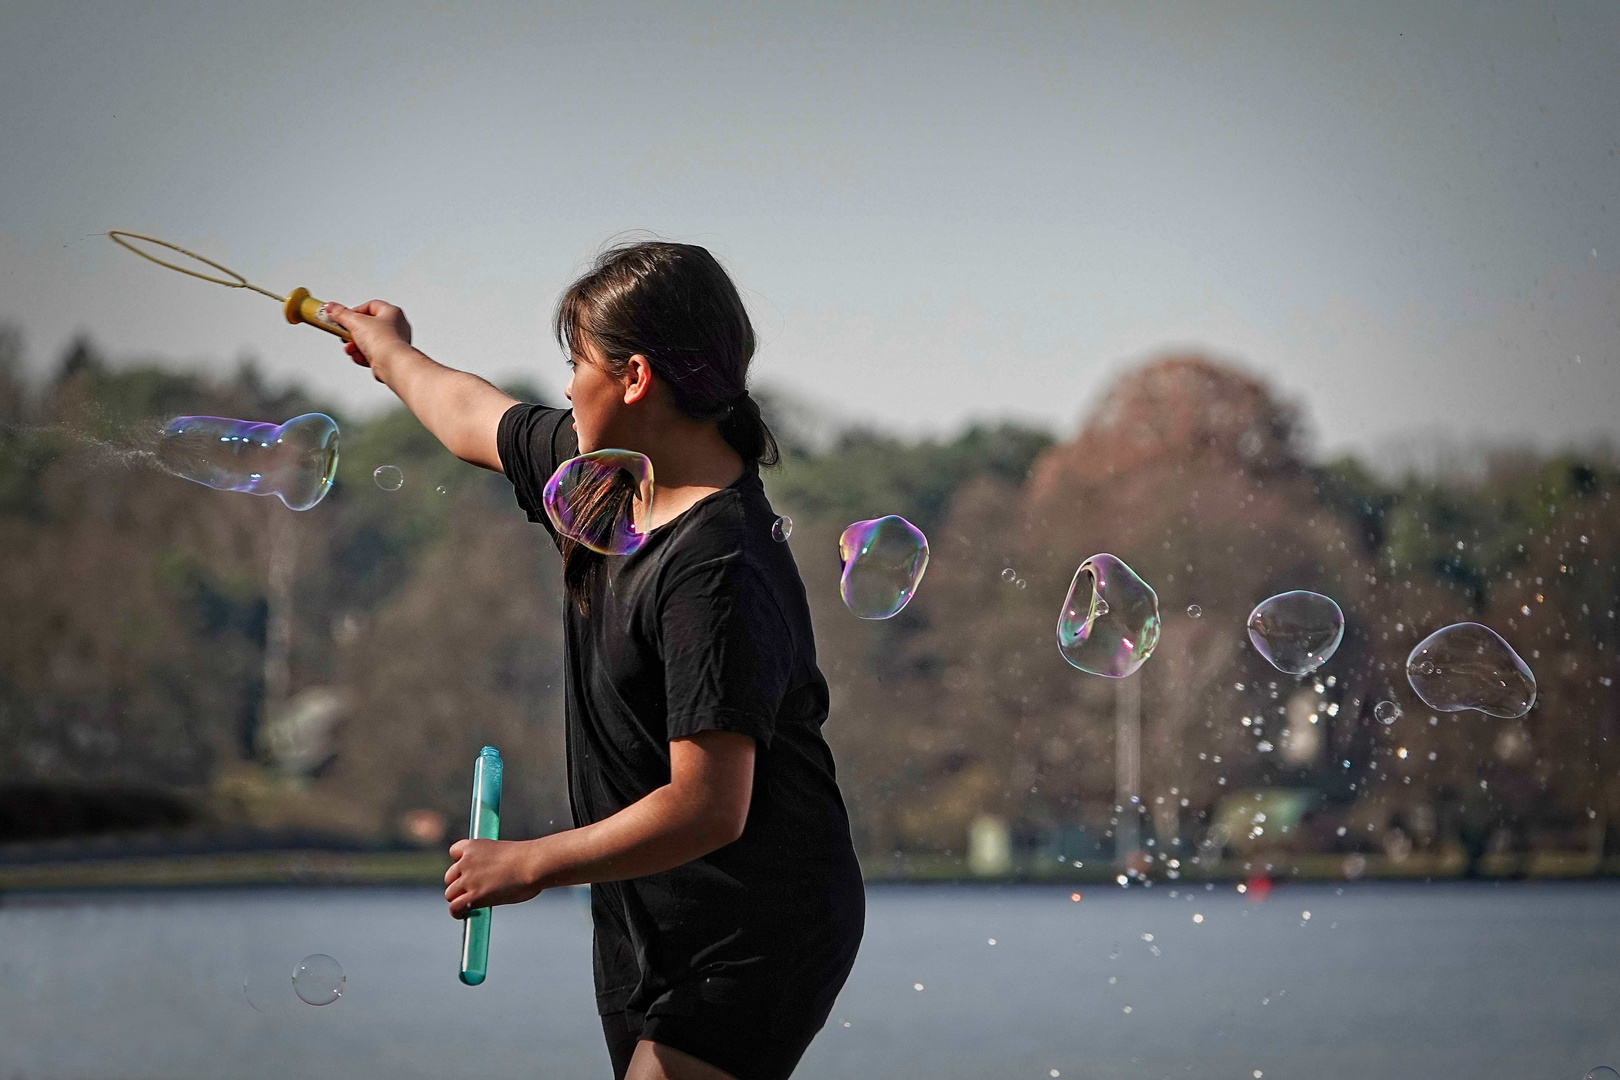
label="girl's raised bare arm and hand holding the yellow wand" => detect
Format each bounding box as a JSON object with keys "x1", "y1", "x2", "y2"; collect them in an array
[{"x1": 322, "y1": 300, "x2": 517, "y2": 473}]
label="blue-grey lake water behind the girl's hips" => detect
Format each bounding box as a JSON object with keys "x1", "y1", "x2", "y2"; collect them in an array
[{"x1": 0, "y1": 882, "x2": 1620, "y2": 1080}]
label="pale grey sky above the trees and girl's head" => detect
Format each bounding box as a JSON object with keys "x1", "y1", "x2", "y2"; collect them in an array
[{"x1": 0, "y1": 2, "x2": 1620, "y2": 449}]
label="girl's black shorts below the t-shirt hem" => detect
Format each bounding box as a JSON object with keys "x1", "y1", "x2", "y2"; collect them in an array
[{"x1": 603, "y1": 887, "x2": 865, "y2": 1080}]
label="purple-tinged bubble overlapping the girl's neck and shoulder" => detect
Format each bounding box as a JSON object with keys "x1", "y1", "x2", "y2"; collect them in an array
[{"x1": 537, "y1": 450, "x2": 653, "y2": 555}]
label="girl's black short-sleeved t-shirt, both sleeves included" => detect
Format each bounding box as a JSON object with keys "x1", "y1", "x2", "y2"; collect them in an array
[{"x1": 497, "y1": 405, "x2": 860, "y2": 1014}]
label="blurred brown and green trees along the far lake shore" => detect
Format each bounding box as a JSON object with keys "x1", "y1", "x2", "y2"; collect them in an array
[{"x1": 0, "y1": 330, "x2": 1620, "y2": 863}]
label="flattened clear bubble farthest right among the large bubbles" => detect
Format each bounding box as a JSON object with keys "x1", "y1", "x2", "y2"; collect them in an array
[{"x1": 1406, "y1": 622, "x2": 1536, "y2": 719}]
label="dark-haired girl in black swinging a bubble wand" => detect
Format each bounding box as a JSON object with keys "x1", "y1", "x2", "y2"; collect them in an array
[{"x1": 327, "y1": 243, "x2": 865, "y2": 1080}]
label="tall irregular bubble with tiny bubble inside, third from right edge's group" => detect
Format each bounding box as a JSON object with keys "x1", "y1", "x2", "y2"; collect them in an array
[{"x1": 1058, "y1": 552, "x2": 1160, "y2": 678}]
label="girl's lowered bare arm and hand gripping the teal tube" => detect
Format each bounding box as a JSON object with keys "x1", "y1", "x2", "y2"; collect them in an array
[{"x1": 444, "y1": 732, "x2": 755, "y2": 918}]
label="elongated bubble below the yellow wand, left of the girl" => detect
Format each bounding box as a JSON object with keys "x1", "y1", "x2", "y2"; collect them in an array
[{"x1": 157, "y1": 413, "x2": 339, "y2": 510}]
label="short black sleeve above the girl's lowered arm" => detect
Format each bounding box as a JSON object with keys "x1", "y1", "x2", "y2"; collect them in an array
[{"x1": 659, "y1": 555, "x2": 794, "y2": 746}]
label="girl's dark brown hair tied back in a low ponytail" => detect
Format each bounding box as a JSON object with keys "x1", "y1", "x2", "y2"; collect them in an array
[{"x1": 552, "y1": 240, "x2": 779, "y2": 612}]
